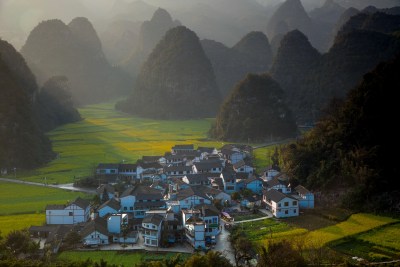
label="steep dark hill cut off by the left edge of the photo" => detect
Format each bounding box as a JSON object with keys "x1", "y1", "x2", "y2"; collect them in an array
[{"x1": 0, "y1": 40, "x2": 54, "y2": 170}]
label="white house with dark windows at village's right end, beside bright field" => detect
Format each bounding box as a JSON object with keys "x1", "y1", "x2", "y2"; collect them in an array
[{"x1": 263, "y1": 189, "x2": 299, "y2": 218}]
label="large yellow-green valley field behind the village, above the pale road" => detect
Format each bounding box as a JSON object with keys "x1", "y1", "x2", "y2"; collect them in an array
[{"x1": 10, "y1": 103, "x2": 228, "y2": 183}]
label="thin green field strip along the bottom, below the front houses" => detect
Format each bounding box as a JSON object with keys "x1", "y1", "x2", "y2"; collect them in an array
[{"x1": 58, "y1": 251, "x2": 188, "y2": 267}]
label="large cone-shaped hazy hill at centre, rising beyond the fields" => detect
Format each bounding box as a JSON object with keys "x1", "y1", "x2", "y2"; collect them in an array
[{"x1": 117, "y1": 26, "x2": 221, "y2": 119}]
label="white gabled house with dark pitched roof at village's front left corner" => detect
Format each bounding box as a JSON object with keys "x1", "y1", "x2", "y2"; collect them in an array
[{"x1": 80, "y1": 218, "x2": 109, "y2": 246}]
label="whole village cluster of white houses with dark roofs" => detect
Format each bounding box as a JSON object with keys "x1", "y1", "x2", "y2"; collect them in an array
[{"x1": 30, "y1": 145, "x2": 314, "y2": 251}]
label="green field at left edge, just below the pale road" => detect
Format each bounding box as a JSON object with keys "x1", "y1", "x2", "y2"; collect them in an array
[{"x1": 0, "y1": 182, "x2": 86, "y2": 216}]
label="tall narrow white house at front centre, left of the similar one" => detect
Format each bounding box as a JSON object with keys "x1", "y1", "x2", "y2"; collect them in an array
[{"x1": 142, "y1": 214, "x2": 164, "y2": 247}]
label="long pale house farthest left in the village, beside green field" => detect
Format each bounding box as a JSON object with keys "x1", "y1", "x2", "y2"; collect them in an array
[{"x1": 46, "y1": 197, "x2": 90, "y2": 224}]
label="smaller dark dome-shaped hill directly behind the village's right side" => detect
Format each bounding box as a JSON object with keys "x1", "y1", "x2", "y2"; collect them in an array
[{"x1": 210, "y1": 74, "x2": 297, "y2": 142}]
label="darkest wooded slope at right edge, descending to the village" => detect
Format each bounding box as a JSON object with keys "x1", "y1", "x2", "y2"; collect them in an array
[{"x1": 282, "y1": 57, "x2": 400, "y2": 211}]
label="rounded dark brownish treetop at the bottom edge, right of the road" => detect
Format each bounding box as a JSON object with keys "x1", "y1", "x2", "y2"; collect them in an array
[{"x1": 257, "y1": 240, "x2": 307, "y2": 267}]
